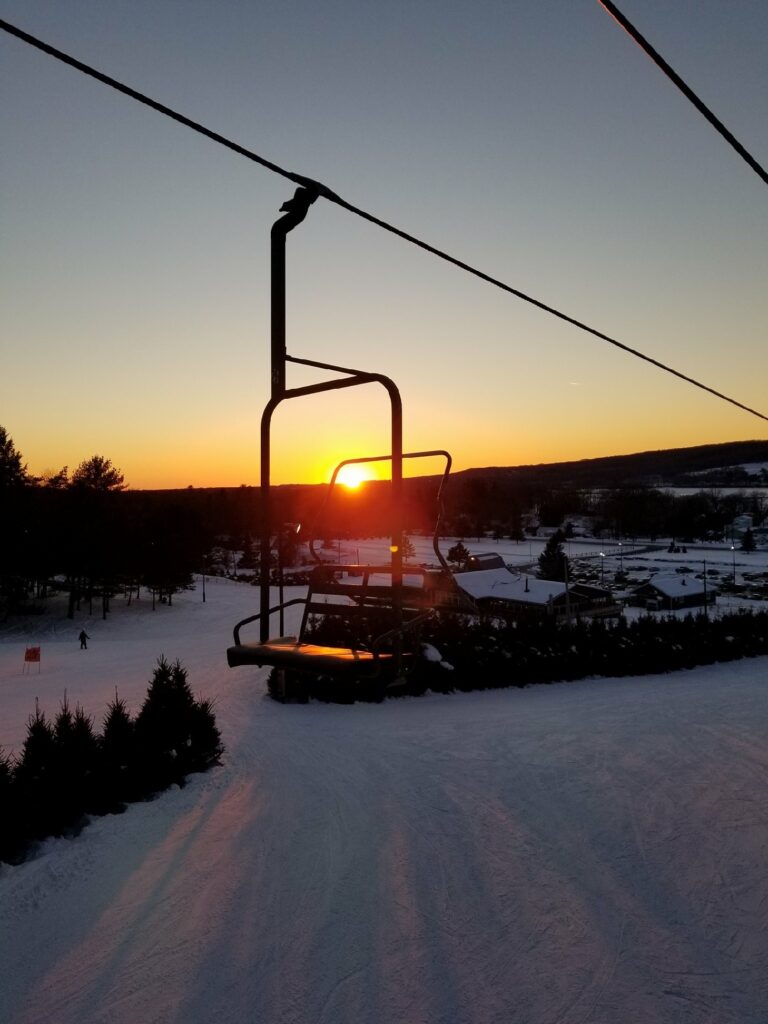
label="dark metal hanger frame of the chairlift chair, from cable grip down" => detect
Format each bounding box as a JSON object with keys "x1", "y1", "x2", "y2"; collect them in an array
[{"x1": 259, "y1": 186, "x2": 402, "y2": 643}]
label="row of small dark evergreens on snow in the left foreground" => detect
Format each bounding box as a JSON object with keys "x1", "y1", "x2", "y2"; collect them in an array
[{"x1": 0, "y1": 657, "x2": 223, "y2": 863}]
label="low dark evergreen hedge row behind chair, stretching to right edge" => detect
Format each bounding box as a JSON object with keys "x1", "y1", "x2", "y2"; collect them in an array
[{"x1": 280, "y1": 611, "x2": 768, "y2": 703}]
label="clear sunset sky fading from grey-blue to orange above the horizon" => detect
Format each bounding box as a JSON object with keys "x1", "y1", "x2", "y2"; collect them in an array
[{"x1": 0, "y1": 0, "x2": 768, "y2": 487}]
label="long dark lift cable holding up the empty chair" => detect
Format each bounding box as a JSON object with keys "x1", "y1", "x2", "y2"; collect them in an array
[{"x1": 0, "y1": 18, "x2": 768, "y2": 422}]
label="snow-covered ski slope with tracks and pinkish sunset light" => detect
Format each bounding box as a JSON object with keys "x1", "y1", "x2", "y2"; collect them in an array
[{"x1": 0, "y1": 573, "x2": 768, "y2": 1024}]
